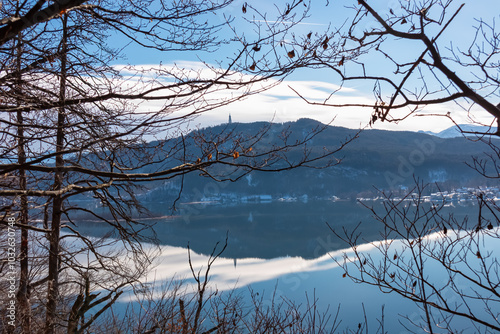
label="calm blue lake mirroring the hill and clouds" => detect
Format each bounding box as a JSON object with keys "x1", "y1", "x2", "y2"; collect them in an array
[{"x1": 76, "y1": 200, "x2": 494, "y2": 333}]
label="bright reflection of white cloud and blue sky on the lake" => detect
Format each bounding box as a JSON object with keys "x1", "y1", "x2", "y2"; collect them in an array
[{"x1": 114, "y1": 227, "x2": 498, "y2": 334}]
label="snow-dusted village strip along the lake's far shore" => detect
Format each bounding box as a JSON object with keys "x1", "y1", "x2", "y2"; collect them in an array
[{"x1": 189, "y1": 186, "x2": 500, "y2": 206}]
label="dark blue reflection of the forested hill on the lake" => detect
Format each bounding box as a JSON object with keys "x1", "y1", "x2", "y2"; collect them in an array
[{"x1": 76, "y1": 200, "x2": 475, "y2": 259}]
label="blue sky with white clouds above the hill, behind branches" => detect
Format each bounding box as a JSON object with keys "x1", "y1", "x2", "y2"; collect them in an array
[{"x1": 112, "y1": 0, "x2": 500, "y2": 132}]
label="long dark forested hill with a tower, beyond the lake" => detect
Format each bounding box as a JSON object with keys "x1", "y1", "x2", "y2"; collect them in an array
[{"x1": 139, "y1": 119, "x2": 500, "y2": 201}]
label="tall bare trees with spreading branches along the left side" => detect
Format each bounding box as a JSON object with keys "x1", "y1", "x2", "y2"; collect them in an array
[{"x1": 0, "y1": 0, "x2": 356, "y2": 334}]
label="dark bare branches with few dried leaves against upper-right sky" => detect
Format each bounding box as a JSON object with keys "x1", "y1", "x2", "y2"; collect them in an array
[{"x1": 290, "y1": 0, "x2": 500, "y2": 134}]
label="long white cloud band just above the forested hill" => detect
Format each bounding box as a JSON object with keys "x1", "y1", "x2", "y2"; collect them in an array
[{"x1": 117, "y1": 61, "x2": 491, "y2": 132}]
